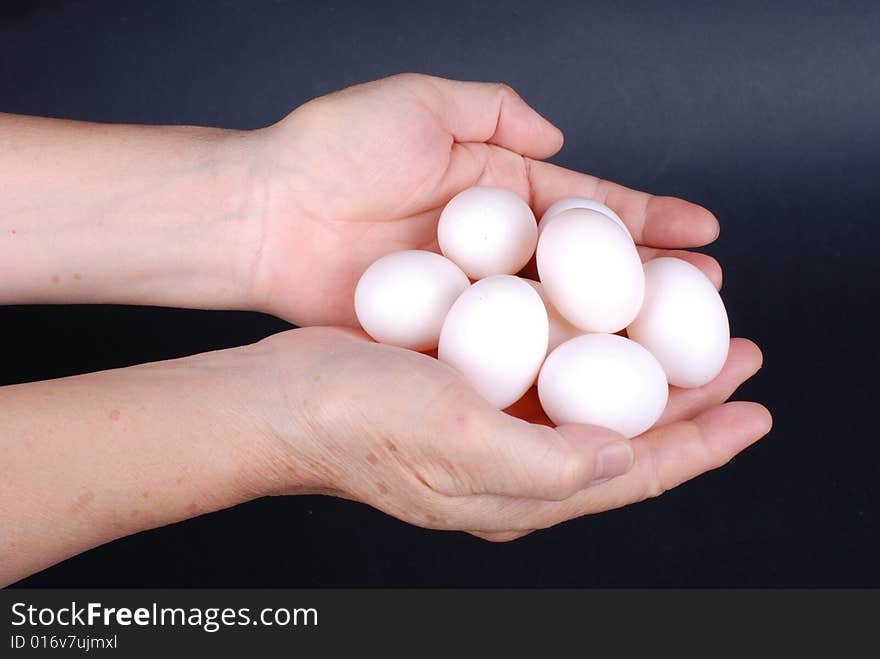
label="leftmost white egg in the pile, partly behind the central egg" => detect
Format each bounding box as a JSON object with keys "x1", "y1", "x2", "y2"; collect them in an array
[{"x1": 354, "y1": 250, "x2": 470, "y2": 351}]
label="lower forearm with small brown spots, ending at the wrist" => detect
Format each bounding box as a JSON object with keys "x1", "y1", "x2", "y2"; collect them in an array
[{"x1": 0, "y1": 344, "x2": 295, "y2": 584}]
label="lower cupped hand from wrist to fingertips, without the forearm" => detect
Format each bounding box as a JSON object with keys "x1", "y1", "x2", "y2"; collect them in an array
[{"x1": 249, "y1": 328, "x2": 771, "y2": 541}]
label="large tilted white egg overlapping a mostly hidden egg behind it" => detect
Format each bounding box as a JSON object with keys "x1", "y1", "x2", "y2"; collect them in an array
[{"x1": 537, "y1": 208, "x2": 645, "y2": 333}]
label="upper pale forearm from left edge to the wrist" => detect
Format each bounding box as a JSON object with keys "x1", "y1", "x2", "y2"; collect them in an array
[{"x1": 0, "y1": 114, "x2": 260, "y2": 309}]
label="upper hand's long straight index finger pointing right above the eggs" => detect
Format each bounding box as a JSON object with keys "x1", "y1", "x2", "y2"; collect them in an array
[{"x1": 528, "y1": 161, "x2": 719, "y2": 248}]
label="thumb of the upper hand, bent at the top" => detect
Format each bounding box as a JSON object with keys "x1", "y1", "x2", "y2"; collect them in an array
[{"x1": 411, "y1": 75, "x2": 563, "y2": 159}]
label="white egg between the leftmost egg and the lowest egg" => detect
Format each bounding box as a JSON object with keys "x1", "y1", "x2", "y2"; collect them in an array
[{"x1": 437, "y1": 275, "x2": 549, "y2": 409}]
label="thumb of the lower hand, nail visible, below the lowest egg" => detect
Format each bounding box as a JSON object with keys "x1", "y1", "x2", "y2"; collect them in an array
[{"x1": 455, "y1": 406, "x2": 633, "y2": 500}]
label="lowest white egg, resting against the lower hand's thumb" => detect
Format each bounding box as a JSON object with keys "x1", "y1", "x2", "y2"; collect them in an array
[{"x1": 538, "y1": 334, "x2": 669, "y2": 437}]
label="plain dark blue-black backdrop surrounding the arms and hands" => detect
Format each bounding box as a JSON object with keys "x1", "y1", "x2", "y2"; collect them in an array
[{"x1": 0, "y1": 1, "x2": 880, "y2": 587}]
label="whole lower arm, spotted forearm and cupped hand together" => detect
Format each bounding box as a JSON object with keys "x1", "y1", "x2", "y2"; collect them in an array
[{"x1": 0, "y1": 320, "x2": 770, "y2": 585}]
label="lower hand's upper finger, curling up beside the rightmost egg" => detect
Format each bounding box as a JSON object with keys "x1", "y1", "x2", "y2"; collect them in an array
[{"x1": 655, "y1": 339, "x2": 764, "y2": 427}]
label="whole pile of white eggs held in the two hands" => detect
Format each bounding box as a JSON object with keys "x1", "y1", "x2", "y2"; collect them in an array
[{"x1": 355, "y1": 187, "x2": 730, "y2": 437}]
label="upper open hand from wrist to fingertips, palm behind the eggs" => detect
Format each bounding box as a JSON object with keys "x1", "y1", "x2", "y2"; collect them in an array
[{"x1": 247, "y1": 74, "x2": 721, "y2": 325}]
